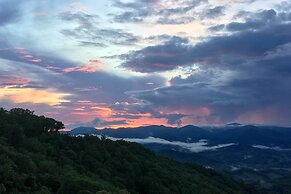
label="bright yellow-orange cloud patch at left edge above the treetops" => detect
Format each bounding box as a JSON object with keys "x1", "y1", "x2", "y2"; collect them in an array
[{"x1": 0, "y1": 87, "x2": 70, "y2": 106}]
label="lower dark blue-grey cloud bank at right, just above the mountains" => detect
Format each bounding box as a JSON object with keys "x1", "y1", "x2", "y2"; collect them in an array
[{"x1": 124, "y1": 45, "x2": 291, "y2": 125}]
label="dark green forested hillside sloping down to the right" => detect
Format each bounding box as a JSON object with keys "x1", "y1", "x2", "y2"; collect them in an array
[{"x1": 0, "y1": 109, "x2": 259, "y2": 194}]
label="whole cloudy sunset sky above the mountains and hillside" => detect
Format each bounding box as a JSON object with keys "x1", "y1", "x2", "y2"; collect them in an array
[{"x1": 0, "y1": 0, "x2": 291, "y2": 128}]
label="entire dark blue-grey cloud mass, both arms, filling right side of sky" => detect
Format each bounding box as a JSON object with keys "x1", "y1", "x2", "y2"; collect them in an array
[{"x1": 119, "y1": 7, "x2": 291, "y2": 125}]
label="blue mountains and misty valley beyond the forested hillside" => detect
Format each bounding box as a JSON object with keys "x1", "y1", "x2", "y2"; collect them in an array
[{"x1": 68, "y1": 123, "x2": 291, "y2": 193}]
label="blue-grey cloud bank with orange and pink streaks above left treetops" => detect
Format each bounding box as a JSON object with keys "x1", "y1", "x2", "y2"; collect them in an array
[{"x1": 0, "y1": 47, "x2": 166, "y2": 126}]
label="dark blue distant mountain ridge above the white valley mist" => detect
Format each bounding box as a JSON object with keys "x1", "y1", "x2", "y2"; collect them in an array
[{"x1": 68, "y1": 123, "x2": 291, "y2": 149}]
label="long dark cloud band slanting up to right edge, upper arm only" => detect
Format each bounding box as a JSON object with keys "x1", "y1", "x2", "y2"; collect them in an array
[{"x1": 122, "y1": 16, "x2": 291, "y2": 73}]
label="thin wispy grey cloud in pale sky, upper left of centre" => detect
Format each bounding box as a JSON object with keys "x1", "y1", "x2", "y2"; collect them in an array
[{"x1": 60, "y1": 12, "x2": 140, "y2": 47}]
